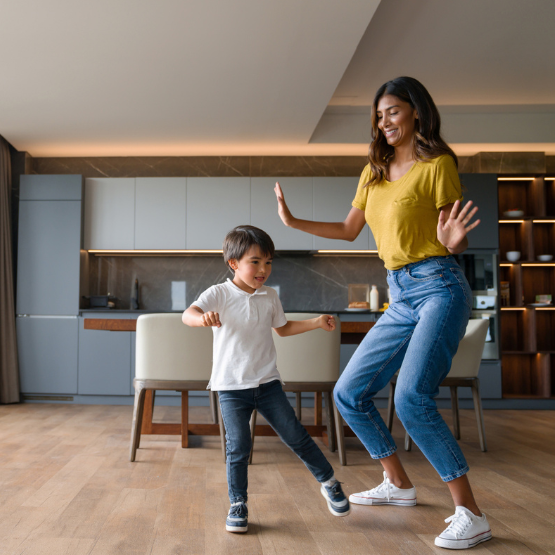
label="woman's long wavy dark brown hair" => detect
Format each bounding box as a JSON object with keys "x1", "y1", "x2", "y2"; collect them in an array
[{"x1": 367, "y1": 77, "x2": 458, "y2": 185}]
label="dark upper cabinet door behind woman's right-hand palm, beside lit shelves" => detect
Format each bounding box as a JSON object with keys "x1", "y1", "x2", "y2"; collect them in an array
[{"x1": 460, "y1": 173, "x2": 499, "y2": 249}]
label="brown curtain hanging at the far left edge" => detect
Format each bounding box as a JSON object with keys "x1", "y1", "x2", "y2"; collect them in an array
[{"x1": 0, "y1": 136, "x2": 19, "y2": 403}]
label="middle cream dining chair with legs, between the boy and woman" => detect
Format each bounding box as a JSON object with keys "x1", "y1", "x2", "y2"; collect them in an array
[{"x1": 247, "y1": 313, "x2": 346, "y2": 465}]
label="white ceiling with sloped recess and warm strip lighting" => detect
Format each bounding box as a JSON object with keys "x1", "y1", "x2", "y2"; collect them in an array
[{"x1": 0, "y1": 0, "x2": 555, "y2": 156}]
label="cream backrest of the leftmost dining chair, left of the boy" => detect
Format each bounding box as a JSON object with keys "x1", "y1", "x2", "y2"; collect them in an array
[{"x1": 135, "y1": 314, "x2": 212, "y2": 381}]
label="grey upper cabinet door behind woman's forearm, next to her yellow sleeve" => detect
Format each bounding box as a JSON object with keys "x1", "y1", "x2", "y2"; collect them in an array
[{"x1": 313, "y1": 177, "x2": 369, "y2": 251}]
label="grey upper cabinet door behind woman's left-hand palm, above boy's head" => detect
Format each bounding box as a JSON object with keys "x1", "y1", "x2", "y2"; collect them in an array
[{"x1": 251, "y1": 177, "x2": 313, "y2": 251}]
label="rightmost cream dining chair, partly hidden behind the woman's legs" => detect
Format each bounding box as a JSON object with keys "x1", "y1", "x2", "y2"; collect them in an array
[{"x1": 387, "y1": 319, "x2": 489, "y2": 451}]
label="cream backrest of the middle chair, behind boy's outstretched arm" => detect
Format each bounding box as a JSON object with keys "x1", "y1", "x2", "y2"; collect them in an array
[{"x1": 274, "y1": 312, "x2": 341, "y2": 384}]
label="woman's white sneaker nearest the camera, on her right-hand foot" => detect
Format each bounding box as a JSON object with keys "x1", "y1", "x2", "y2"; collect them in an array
[{"x1": 435, "y1": 507, "x2": 491, "y2": 549}]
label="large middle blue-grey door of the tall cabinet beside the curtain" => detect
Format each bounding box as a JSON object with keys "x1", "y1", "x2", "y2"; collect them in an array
[{"x1": 16, "y1": 200, "x2": 81, "y2": 315}]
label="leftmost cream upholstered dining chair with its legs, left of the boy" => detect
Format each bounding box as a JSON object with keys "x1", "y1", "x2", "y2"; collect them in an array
[{"x1": 129, "y1": 313, "x2": 223, "y2": 462}]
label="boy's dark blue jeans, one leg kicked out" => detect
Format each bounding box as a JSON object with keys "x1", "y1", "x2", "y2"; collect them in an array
[{"x1": 218, "y1": 380, "x2": 333, "y2": 503}]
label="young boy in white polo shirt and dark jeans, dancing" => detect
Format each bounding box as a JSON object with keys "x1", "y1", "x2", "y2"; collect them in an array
[{"x1": 183, "y1": 225, "x2": 350, "y2": 532}]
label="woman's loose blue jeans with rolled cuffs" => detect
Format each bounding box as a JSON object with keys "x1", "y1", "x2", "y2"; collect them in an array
[{"x1": 334, "y1": 256, "x2": 472, "y2": 482}]
